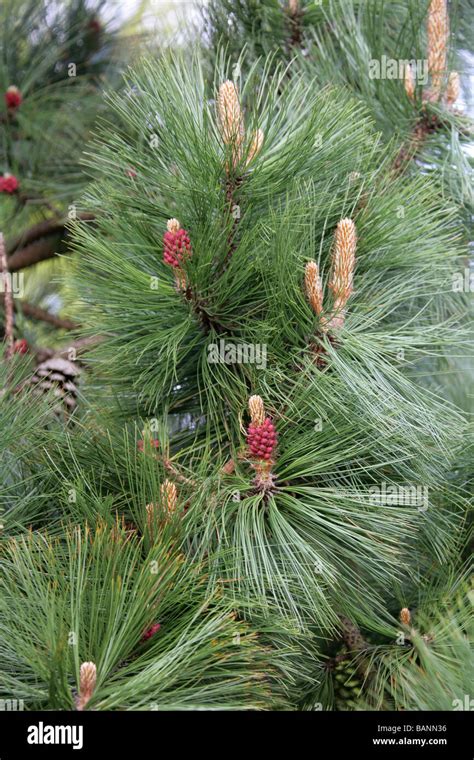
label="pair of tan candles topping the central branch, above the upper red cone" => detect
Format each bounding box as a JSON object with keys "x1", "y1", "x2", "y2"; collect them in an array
[{"x1": 217, "y1": 79, "x2": 264, "y2": 172}]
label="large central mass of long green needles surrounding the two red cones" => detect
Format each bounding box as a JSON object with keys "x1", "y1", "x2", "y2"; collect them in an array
[{"x1": 67, "y1": 53, "x2": 466, "y2": 628}]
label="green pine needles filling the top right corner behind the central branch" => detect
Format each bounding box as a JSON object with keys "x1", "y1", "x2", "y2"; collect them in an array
[{"x1": 204, "y1": 0, "x2": 473, "y2": 220}]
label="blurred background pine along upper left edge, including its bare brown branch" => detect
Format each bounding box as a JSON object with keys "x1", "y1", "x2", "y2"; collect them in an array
[{"x1": 0, "y1": 0, "x2": 137, "y2": 351}]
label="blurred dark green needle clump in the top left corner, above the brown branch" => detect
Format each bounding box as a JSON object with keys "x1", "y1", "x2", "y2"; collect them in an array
[{"x1": 0, "y1": 0, "x2": 130, "y2": 214}]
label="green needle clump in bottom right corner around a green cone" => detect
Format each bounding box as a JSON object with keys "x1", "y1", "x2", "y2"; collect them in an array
[{"x1": 302, "y1": 563, "x2": 472, "y2": 711}]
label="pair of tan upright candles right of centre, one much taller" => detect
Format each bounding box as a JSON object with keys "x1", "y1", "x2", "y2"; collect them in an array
[{"x1": 305, "y1": 219, "x2": 357, "y2": 332}]
